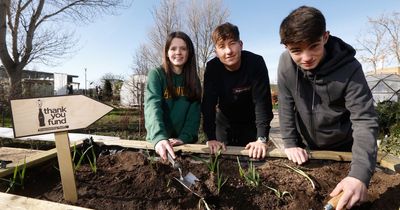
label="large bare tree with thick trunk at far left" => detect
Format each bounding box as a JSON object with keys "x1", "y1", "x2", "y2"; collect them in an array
[{"x1": 0, "y1": 0, "x2": 130, "y2": 98}]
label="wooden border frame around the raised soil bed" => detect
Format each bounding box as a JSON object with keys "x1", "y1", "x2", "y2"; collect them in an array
[{"x1": 0, "y1": 140, "x2": 400, "y2": 210}]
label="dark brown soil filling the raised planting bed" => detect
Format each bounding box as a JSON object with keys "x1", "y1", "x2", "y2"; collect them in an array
[{"x1": 0, "y1": 144, "x2": 400, "y2": 210}]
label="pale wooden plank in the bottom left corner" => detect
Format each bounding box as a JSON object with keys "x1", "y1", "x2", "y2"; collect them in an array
[{"x1": 0, "y1": 193, "x2": 90, "y2": 210}]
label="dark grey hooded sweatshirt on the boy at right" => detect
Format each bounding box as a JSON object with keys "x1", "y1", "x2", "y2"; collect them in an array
[{"x1": 278, "y1": 36, "x2": 378, "y2": 187}]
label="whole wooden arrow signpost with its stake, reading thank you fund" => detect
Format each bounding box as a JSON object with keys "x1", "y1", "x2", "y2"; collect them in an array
[{"x1": 10, "y1": 95, "x2": 113, "y2": 202}]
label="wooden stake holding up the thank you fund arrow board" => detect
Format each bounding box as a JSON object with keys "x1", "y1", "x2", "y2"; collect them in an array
[{"x1": 54, "y1": 131, "x2": 78, "y2": 203}]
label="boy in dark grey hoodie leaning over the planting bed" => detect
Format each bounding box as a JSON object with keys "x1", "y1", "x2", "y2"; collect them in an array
[{"x1": 278, "y1": 6, "x2": 378, "y2": 209}]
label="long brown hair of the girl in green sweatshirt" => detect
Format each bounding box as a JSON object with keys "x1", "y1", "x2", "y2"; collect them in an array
[{"x1": 162, "y1": 31, "x2": 201, "y2": 101}]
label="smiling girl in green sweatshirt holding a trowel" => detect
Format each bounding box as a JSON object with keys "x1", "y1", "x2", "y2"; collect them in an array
[{"x1": 144, "y1": 31, "x2": 201, "y2": 160}]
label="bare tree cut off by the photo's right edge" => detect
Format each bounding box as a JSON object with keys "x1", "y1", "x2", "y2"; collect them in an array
[{"x1": 370, "y1": 12, "x2": 400, "y2": 65}]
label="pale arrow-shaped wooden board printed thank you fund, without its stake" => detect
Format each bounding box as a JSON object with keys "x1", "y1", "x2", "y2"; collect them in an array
[{"x1": 11, "y1": 95, "x2": 113, "y2": 138}]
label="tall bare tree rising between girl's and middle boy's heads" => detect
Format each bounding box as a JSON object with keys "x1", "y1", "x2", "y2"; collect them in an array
[{"x1": 187, "y1": 0, "x2": 229, "y2": 70}]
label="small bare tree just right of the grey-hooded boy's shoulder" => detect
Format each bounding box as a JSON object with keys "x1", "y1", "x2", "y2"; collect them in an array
[{"x1": 357, "y1": 18, "x2": 387, "y2": 74}]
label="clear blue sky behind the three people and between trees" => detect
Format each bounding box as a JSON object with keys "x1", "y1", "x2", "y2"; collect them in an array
[{"x1": 29, "y1": 0, "x2": 400, "y2": 88}]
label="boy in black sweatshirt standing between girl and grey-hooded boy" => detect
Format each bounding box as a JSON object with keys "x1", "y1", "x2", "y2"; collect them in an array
[{"x1": 202, "y1": 23, "x2": 273, "y2": 158}]
